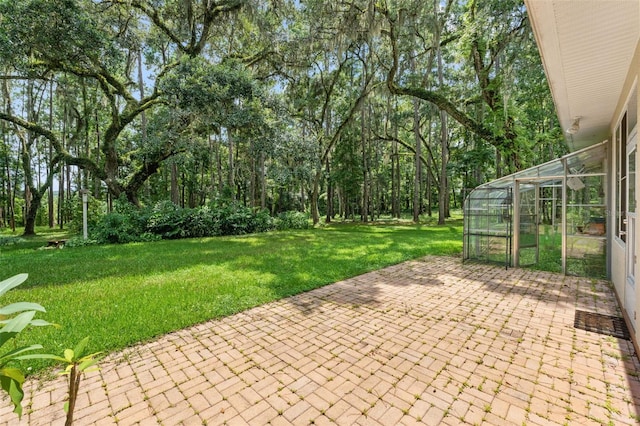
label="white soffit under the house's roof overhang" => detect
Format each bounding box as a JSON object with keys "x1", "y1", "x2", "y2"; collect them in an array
[{"x1": 525, "y1": 0, "x2": 640, "y2": 150}]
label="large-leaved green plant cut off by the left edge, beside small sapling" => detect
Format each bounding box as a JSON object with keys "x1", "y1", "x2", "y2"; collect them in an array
[{"x1": 0, "y1": 274, "x2": 53, "y2": 417}]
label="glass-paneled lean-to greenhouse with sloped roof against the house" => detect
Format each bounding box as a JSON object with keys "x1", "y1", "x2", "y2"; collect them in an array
[{"x1": 463, "y1": 141, "x2": 608, "y2": 278}]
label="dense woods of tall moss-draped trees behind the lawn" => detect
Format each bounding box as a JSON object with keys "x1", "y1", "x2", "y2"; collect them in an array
[{"x1": 0, "y1": 0, "x2": 565, "y2": 235}]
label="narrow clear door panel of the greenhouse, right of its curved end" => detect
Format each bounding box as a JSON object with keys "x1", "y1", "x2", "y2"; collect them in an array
[{"x1": 514, "y1": 182, "x2": 540, "y2": 266}]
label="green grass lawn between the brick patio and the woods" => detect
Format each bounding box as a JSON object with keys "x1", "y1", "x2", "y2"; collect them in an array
[{"x1": 0, "y1": 220, "x2": 462, "y2": 372}]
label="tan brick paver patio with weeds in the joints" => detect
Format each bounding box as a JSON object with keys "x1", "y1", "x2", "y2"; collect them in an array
[{"x1": 0, "y1": 257, "x2": 640, "y2": 425}]
